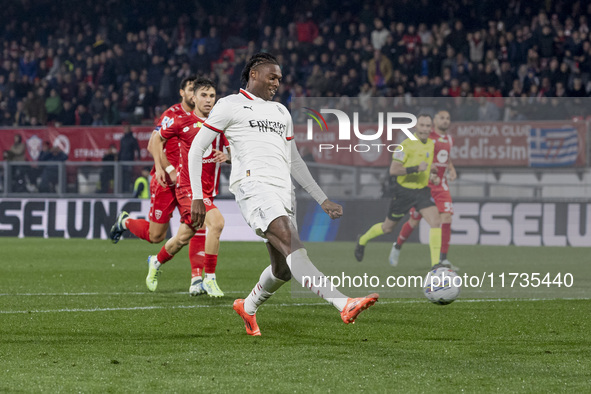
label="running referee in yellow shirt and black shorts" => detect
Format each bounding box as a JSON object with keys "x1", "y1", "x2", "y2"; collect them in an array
[{"x1": 354, "y1": 115, "x2": 441, "y2": 265}]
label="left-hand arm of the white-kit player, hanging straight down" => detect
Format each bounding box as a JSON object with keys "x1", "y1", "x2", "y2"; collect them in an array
[{"x1": 189, "y1": 127, "x2": 218, "y2": 228}]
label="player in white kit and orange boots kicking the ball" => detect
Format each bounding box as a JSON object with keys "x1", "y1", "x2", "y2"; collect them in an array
[{"x1": 189, "y1": 53, "x2": 379, "y2": 336}]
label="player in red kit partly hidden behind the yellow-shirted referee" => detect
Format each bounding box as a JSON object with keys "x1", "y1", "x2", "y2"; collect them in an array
[{"x1": 389, "y1": 110, "x2": 458, "y2": 270}]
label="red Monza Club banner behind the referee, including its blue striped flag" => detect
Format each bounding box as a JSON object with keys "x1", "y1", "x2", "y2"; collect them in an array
[{"x1": 295, "y1": 120, "x2": 588, "y2": 167}]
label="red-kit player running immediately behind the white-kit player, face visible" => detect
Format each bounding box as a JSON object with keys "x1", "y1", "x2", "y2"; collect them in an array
[{"x1": 146, "y1": 77, "x2": 228, "y2": 297}]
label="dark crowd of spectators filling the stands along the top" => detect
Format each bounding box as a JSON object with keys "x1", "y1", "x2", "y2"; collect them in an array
[{"x1": 0, "y1": 0, "x2": 591, "y2": 126}]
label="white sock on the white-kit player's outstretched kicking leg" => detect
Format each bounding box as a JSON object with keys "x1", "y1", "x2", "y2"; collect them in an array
[{"x1": 287, "y1": 248, "x2": 348, "y2": 311}]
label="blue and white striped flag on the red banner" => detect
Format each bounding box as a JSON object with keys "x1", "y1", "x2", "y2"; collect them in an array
[{"x1": 529, "y1": 127, "x2": 579, "y2": 167}]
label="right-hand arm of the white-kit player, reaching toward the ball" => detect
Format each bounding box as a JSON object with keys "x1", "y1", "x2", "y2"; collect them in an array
[{"x1": 290, "y1": 141, "x2": 343, "y2": 219}]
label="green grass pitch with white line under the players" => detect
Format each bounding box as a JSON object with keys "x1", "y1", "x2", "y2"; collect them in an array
[{"x1": 0, "y1": 238, "x2": 591, "y2": 393}]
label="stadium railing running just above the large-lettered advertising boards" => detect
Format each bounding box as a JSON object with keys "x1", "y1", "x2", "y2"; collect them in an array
[{"x1": 0, "y1": 161, "x2": 591, "y2": 200}]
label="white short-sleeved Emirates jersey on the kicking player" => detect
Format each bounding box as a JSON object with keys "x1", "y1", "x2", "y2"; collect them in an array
[{"x1": 203, "y1": 89, "x2": 294, "y2": 194}]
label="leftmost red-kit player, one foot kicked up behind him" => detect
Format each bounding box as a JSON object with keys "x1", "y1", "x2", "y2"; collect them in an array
[{"x1": 109, "y1": 75, "x2": 215, "y2": 295}]
